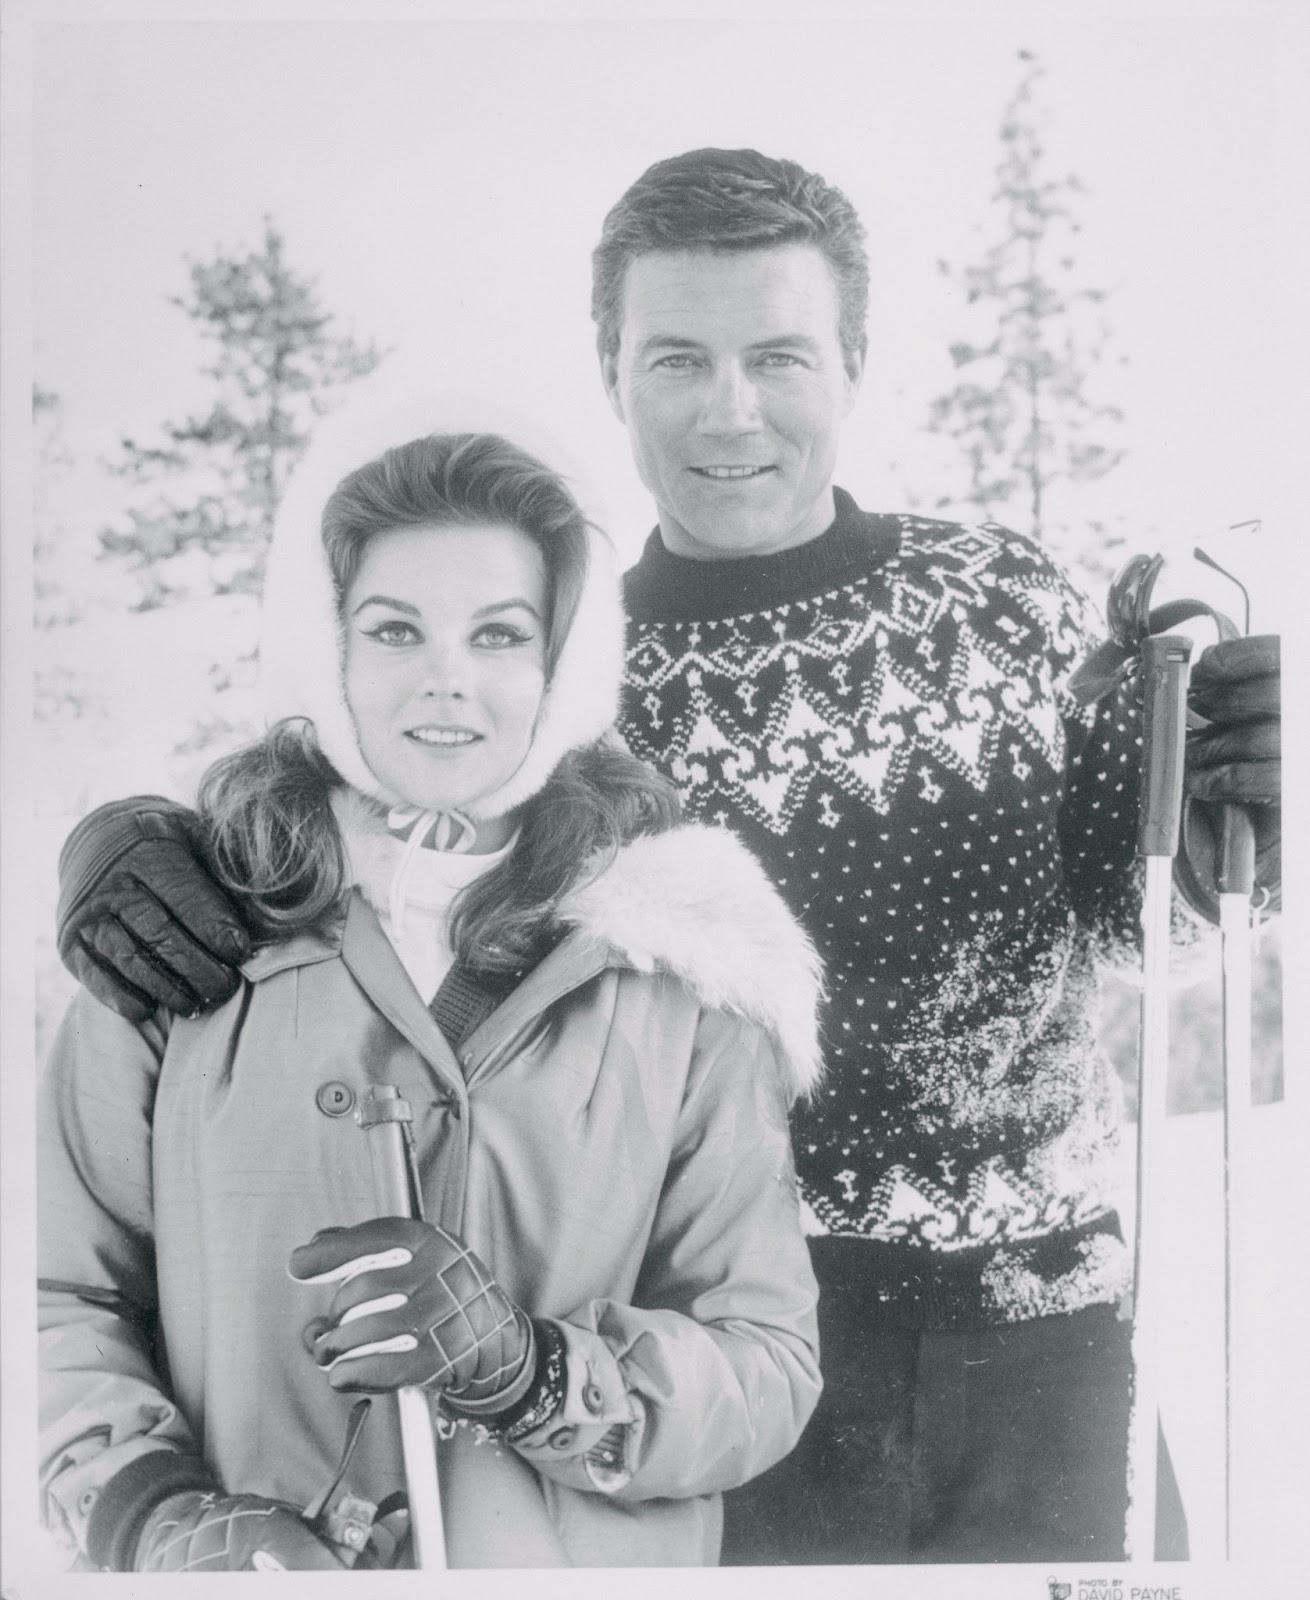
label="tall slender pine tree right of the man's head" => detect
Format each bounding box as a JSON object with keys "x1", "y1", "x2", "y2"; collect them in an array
[{"x1": 928, "y1": 51, "x2": 1124, "y2": 574}]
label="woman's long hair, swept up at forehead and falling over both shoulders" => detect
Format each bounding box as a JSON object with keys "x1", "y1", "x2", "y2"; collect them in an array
[{"x1": 198, "y1": 434, "x2": 678, "y2": 976}]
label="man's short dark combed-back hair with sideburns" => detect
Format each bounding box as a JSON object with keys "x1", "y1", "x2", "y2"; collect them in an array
[{"x1": 592, "y1": 150, "x2": 869, "y2": 355}]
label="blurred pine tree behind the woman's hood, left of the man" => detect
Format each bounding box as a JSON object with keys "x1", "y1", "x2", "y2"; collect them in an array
[{"x1": 101, "y1": 218, "x2": 382, "y2": 608}]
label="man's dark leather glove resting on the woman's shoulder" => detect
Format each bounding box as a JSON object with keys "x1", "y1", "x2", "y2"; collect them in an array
[{"x1": 58, "y1": 795, "x2": 251, "y2": 1022}]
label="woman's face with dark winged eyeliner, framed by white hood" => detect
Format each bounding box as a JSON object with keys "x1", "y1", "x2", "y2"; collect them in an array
[{"x1": 342, "y1": 525, "x2": 547, "y2": 851}]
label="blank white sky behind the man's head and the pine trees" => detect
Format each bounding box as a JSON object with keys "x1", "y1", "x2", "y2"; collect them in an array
[{"x1": 34, "y1": 8, "x2": 1288, "y2": 604}]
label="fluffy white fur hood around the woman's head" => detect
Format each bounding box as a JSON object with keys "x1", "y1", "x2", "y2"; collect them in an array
[{"x1": 261, "y1": 392, "x2": 624, "y2": 821}]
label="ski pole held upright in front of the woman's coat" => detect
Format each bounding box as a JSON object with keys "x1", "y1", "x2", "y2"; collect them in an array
[{"x1": 357, "y1": 1083, "x2": 446, "y2": 1571}]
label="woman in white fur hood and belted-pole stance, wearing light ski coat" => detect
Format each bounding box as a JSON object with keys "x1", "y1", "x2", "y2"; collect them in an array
[{"x1": 40, "y1": 435, "x2": 819, "y2": 1571}]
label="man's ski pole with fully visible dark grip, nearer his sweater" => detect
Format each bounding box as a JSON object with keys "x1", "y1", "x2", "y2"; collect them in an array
[{"x1": 1128, "y1": 634, "x2": 1192, "y2": 1560}]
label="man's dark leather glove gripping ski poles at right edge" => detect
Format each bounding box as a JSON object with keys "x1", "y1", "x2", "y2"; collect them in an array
[{"x1": 1174, "y1": 634, "x2": 1283, "y2": 922}]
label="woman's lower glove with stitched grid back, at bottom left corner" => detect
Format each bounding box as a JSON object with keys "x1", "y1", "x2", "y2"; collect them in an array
[{"x1": 133, "y1": 1490, "x2": 344, "y2": 1573}]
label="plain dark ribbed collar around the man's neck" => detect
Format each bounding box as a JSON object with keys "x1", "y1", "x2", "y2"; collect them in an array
[{"x1": 624, "y1": 488, "x2": 902, "y2": 622}]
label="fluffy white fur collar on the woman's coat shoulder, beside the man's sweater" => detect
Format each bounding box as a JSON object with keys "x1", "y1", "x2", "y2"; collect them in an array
[{"x1": 560, "y1": 826, "x2": 822, "y2": 1096}]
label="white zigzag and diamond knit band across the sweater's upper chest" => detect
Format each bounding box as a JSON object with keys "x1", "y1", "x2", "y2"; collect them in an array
[{"x1": 625, "y1": 525, "x2": 1078, "y2": 835}]
